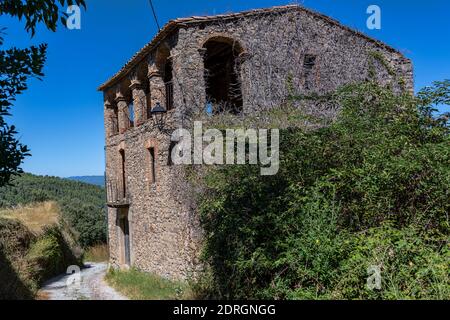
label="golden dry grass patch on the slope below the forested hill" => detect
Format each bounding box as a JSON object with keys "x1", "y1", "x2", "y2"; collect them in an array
[{"x1": 0, "y1": 201, "x2": 60, "y2": 234}]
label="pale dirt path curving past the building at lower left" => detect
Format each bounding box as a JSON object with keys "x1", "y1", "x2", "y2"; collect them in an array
[{"x1": 39, "y1": 262, "x2": 127, "y2": 300}]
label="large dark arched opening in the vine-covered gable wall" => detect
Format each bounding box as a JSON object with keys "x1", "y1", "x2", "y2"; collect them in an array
[{"x1": 203, "y1": 38, "x2": 243, "y2": 114}]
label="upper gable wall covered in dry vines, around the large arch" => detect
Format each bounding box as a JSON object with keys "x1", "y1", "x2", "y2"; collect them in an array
[{"x1": 172, "y1": 11, "x2": 413, "y2": 113}]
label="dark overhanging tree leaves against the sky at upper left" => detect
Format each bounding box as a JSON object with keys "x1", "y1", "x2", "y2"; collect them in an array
[{"x1": 0, "y1": 0, "x2": 85, "y2": 186}]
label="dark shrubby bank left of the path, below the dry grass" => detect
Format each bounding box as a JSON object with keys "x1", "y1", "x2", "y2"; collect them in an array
[{"x1": 0, "y1": 216, "x2": 81, "y2": 300}]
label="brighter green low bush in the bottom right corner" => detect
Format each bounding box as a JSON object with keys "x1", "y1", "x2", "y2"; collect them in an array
[{"x1": 333, "y1": 223, "x2": 450, "y2": 300}]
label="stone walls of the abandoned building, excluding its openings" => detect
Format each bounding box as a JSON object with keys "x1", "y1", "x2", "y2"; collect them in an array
[{"x1": 105, "y1": 6, "x2": 413, "y2": 279}]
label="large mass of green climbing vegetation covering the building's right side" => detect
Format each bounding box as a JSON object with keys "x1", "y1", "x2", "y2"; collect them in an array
[{"x1": 196, "y1": 81, "x2": 450, "y2": 299}]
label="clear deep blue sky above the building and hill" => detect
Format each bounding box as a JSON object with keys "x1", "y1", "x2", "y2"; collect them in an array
[{"x1": 0, "y1": 0, "x2": 450, "y2": 177}]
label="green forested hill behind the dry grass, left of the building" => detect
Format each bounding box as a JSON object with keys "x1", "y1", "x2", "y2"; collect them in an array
[{"x1": 0, "y1": 174, "x2": 106, "y2": 247}]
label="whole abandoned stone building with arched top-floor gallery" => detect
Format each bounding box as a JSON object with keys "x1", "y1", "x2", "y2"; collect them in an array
[{"x1": 99, "y1": 5, "x2": 413, "y2": 279}]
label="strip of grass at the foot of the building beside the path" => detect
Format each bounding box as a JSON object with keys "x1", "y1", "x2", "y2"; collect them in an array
[{"x1": 105, "y1": 268, "x2": 193, "y2": 300}]
